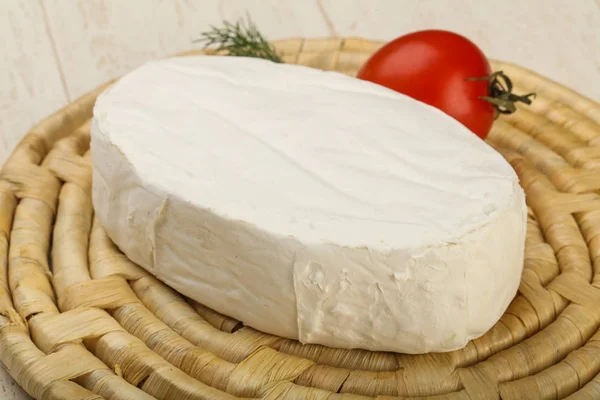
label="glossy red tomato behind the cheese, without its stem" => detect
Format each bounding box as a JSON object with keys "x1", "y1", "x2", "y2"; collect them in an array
[{"x1": 358, "y1": 30, "x2": 495, "y2": 139}]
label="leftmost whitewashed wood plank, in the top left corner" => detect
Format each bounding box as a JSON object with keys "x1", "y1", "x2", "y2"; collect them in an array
[{"x1": 0, "y1": 0, "x2": 67, "y2": 165}]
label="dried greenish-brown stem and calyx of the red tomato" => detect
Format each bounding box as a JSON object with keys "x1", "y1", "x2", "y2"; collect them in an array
[{"x1": 467, "y1": 71, "x2": 536, "y2": 118}]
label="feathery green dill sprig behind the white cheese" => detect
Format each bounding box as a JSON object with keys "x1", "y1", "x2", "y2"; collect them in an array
[{"x1": 194, "y1": 17, "x2": 283, "y2": 63}]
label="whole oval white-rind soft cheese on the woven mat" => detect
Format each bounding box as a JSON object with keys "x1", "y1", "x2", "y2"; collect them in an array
[{"x1": 91, "y1": 56, "x2": 527, "y2": 353}]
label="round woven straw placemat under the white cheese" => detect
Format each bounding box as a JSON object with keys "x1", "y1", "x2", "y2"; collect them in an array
[{"x1": 0, "y1": 39, "x2": 600, "y2": 400}]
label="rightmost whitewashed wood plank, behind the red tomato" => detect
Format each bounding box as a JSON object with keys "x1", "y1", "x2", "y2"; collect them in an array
[{"x1": 322, "y1": 0, "x2": 600, "y2": 101}]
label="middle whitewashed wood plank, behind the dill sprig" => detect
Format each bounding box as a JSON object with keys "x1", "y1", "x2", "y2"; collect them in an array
[{"x1": 44, "y1": 0, "x2": 329, "y2": 97}]
